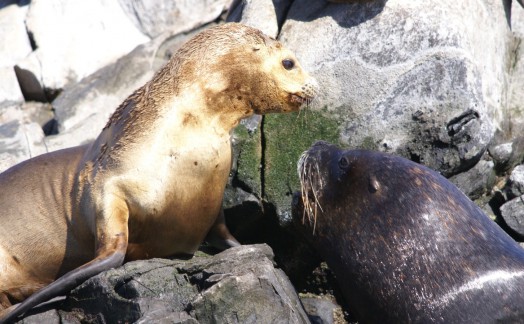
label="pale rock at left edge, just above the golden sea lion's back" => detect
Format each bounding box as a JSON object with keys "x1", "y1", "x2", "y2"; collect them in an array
[{"x1": 0, "y1": 104, "x2": 47, "y2": 172}]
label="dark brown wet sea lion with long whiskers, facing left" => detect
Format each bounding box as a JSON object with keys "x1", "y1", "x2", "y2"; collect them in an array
[{"x1": 293, "y1": 142, "x2": 524, "y2": 323}]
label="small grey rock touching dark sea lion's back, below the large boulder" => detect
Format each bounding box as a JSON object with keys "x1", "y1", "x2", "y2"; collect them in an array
[{"x1": 449, "y1": 160, "x2": 496, "y2": 200}]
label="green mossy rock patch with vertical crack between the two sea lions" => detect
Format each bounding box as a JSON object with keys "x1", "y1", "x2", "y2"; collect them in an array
[{"x1": 224, "y1": 108, "x2": 340, "y2": 223}]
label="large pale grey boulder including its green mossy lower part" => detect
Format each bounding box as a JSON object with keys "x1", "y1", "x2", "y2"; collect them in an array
[{"x1": 226, "y1": 0, "x2": 511, "y2": 223}]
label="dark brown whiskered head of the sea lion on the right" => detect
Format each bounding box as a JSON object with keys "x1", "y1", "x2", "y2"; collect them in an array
[{"x1": 294, "y1": 141, "x2": 406, "y2": 233}]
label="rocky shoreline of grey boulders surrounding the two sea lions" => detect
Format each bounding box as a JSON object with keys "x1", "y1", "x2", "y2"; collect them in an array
[{"x1": 0, "y1": 0, "x2": 524, "y2": 323}]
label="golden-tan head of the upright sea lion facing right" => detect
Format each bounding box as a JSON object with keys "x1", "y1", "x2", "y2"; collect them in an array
[{"x1": 171, "y1": 23, "x2": 317, "y2": 117}]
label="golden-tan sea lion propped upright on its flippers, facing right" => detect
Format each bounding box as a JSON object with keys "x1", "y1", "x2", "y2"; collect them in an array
[{"x1": 0, "y1": 23, "x2": 316, "y2": 321}]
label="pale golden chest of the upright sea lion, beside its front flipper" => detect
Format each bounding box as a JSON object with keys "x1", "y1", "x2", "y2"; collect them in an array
[{"x1": 115, "y1": 126, "x2": 231, "y2": 258}]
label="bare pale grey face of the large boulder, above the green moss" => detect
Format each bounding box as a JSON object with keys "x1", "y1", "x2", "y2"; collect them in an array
[{"x1": 280, "y1": 1, "x2": 502, "y2": 176}]
